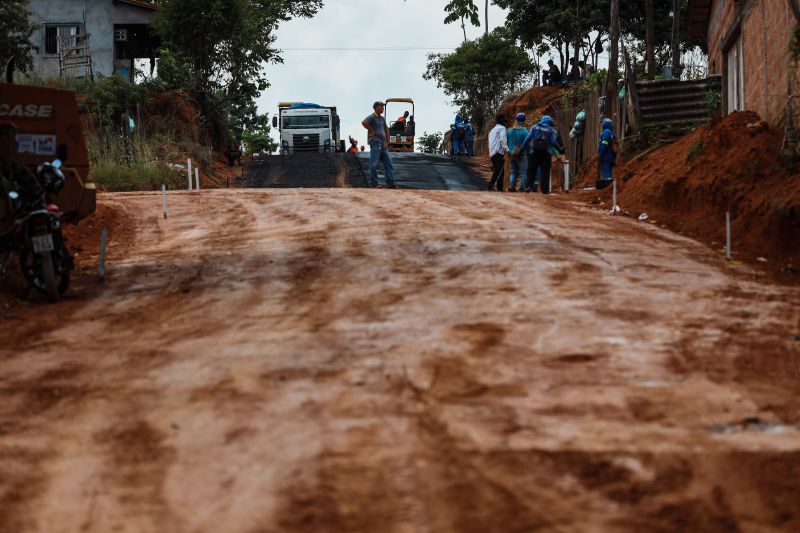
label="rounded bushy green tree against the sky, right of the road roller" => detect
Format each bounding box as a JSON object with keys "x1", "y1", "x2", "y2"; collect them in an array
[{"x1": 423, "y1": 29, "x2": 534, "y2": 128}]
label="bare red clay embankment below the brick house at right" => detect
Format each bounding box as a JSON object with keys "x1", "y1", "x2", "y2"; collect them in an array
[{"x1": 604, "y1": 112, "x2": 800, "y2": 271}]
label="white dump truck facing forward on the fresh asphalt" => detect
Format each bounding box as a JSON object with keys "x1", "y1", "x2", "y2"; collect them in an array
[{"x1": 272, "y1": 102, "x2": 344, "y2": 155}]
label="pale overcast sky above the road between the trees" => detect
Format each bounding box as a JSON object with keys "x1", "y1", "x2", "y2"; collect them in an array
[{"x1": 258, "y1": 0, "x2": 505, "y2": 149}]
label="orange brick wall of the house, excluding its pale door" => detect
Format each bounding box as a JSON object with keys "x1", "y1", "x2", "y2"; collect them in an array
[{"x1": 708, "y1": 0, "x2": 800, "y2": 126}]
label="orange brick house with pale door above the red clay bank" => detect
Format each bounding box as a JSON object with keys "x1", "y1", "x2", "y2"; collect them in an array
[{"x1": 686, "y1": 0, "x2": 800, "y2": 126}]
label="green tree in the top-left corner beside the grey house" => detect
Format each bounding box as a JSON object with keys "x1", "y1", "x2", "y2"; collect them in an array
[{"x1": 0, "y1": 0, "x2": 38, "y2": 72}]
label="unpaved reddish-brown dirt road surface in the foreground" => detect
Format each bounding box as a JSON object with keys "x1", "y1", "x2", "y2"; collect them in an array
[{"x1": 0, "y1": 189, "x2": 800, "y2": 533}]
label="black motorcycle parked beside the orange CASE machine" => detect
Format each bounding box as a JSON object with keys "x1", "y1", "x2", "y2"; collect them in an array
[{"x1": 0, "y1": 161, "x2": 75, "y2": 302}]
